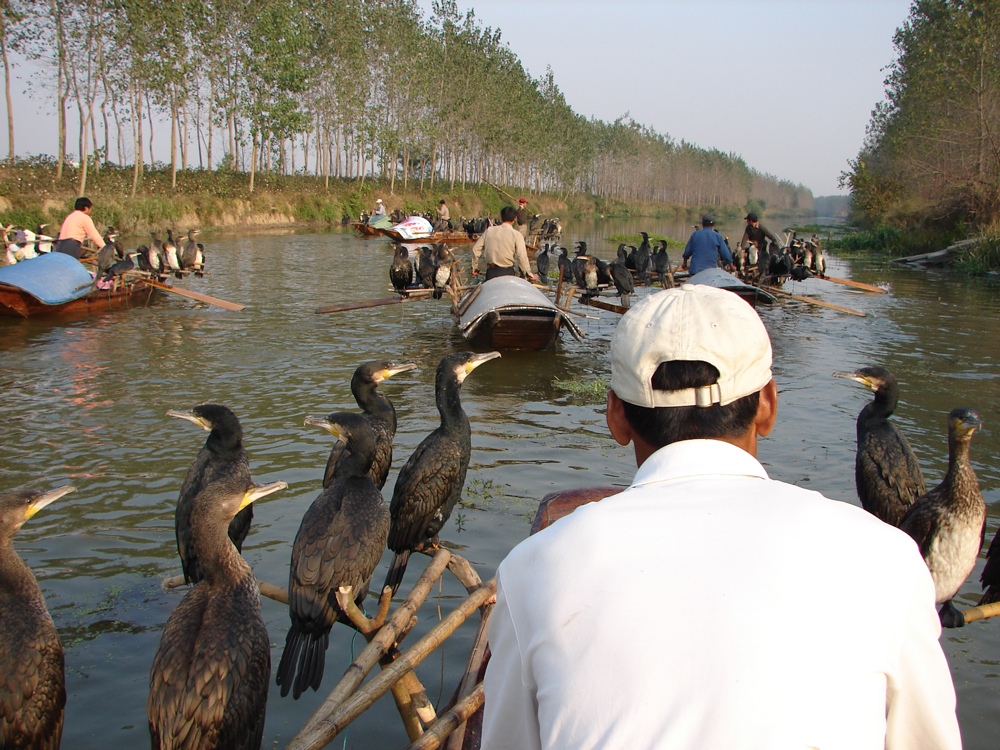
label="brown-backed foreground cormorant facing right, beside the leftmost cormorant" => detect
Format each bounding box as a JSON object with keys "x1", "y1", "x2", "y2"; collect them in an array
[{"x1": 146, "y1": 474, "x2": 287, "y2": 750}]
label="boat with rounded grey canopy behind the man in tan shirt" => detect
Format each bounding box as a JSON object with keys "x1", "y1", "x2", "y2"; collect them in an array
[{"x1": 452, "y1": 276, "x2": 583, "y2": 350}]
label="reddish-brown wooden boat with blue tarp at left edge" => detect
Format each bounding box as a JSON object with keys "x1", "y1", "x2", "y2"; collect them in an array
[{"x1": 0, "y1": 253, "x2": 160, "y2": 318}]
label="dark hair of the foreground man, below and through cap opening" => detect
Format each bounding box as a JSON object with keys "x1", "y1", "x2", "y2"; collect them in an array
[{"x1": 622, "y1": 360, "x2": 760, "y2": 448}]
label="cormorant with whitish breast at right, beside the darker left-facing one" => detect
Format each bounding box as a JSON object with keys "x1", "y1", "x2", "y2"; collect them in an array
[{"x1": 899, "y1": 408, "x2": 986, "y2": 628}]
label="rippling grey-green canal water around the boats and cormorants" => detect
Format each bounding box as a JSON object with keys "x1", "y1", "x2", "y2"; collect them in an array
[{"x1": 0, "y1": 220, "x2": 1000, "y2": 749}]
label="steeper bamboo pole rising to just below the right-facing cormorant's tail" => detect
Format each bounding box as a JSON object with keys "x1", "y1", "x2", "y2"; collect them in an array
[{"x1": 288, "y1": 549, "x2": 451, "y2": 750}]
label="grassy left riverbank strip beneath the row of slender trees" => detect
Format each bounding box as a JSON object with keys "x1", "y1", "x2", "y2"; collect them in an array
[{"x1": 0, "y1": 161, "x2": 811, "y2": 233}]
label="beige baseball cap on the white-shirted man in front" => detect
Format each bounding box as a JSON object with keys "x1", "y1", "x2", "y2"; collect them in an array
[{"x1": 611, "y1": 284, "x2": 771, "y2": 408}]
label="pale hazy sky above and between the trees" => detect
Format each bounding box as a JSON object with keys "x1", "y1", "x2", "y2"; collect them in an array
[{"x1": 0, "y1": 0, "x2": 910, "y2": 195}]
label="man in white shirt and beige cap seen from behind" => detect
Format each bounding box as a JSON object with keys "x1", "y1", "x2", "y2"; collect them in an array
[{"x1": 482, "y1": 284, "x2": 961, "y2": 750}]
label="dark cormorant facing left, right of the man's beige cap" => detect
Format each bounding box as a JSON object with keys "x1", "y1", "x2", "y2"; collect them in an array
[{"x1": 833, "y1": 367, "x2": 927, "y2": 526}]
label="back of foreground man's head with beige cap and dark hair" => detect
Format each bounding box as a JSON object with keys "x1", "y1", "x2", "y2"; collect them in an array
[{"x1": 611, "y1": 284, "x2": 771, "y2": 448}]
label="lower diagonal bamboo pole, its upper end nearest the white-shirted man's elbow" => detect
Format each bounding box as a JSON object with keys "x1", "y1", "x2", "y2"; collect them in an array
[{"x1": 288, "y1": 579, "x2": 496, "y2": 750}]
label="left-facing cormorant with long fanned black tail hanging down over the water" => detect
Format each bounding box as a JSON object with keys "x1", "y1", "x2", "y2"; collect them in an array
[{"x1": 275, "y1": 412, "x2": 389, "y2": 700}]
